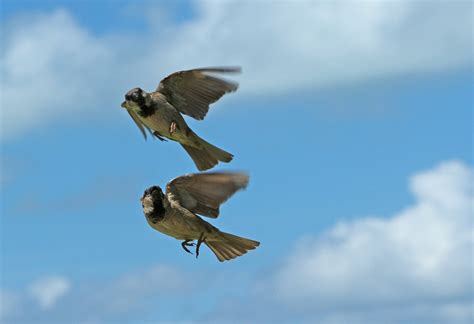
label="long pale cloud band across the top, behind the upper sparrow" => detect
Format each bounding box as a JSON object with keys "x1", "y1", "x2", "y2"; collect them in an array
[{"x1": 0, "y1": 1, "x2": 472, "y2": 138}]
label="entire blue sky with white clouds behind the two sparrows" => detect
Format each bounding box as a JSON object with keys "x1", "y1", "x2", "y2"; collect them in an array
[{"x1": 0, "y1": 0, "x2": 474, "y2": 323}]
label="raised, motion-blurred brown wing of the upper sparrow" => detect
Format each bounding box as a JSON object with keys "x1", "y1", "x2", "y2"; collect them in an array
[{"x1": 156, "y1": 67, "x2": 241, "y2": 120}]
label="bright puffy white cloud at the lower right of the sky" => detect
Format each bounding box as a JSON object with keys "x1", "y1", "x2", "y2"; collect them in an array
[{"x1": 274, "y1": 161, "x2": 474, "y2": 323}]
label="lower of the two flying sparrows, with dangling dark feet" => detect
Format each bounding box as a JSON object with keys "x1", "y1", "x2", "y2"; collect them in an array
[{"x1": 140, "y1": 172, "x2": 260, "y2": 262}]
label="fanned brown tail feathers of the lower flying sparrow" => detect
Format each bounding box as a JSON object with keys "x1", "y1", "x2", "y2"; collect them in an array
[{"x1": 204, "y1": 232, "x2": 260, "y2": 262}]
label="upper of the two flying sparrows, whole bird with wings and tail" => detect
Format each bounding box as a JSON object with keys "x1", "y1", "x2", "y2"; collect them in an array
[{"x1": 121, "y1": 67, "x2": 240, "y2": 171}]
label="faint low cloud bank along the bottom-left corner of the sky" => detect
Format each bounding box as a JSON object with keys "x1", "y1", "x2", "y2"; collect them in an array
[{"x1": 0, "y1": 265, "x2": 198, "y2": 323}]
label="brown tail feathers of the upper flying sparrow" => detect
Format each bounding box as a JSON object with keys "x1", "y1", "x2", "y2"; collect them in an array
[{"x1": 181, "y1": 135, "x2": 234, "y2": 171}]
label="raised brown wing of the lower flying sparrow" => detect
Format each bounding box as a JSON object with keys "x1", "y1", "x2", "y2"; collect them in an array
[{"x1": 166, "y1": 172, "x2": 249, "y2": 218}]
